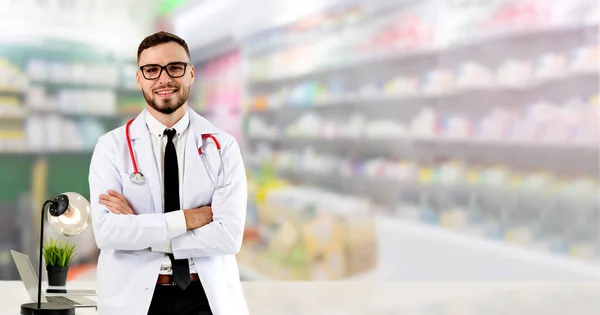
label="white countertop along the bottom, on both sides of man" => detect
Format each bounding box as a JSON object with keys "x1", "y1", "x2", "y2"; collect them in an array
[{"x1": 0, "y1": 281, "x2": 600, "y2": 315}]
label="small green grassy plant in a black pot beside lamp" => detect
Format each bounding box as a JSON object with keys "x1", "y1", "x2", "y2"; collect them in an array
[{"x1": 43, "y1": 238, "x2": 75, "y2": 287}]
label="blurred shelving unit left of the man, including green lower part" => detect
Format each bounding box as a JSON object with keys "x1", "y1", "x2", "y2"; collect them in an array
[{"x1": 0, "y1": 40, "x2": 143, "y2": 266}]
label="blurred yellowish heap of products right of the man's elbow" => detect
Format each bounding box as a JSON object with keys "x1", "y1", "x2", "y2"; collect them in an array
[{"x1": 243, "y1": 180, "x2": 377, "y2": 280}]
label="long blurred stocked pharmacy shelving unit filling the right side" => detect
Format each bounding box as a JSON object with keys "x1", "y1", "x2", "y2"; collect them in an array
[{"x1": 242, "y1": 0, "x2": 600, "y2": 280}]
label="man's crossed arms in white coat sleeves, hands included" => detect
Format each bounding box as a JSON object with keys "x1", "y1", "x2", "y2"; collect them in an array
[{"x1": 89, "y1": 136, "x2": 247, "y2": 259}]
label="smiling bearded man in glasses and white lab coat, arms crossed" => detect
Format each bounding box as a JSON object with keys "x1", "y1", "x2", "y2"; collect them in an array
[{"x1": 89, "y1": 32, "x2": 248, "y2": 315}]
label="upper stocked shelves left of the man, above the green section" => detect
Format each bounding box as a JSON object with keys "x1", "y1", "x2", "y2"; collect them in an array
[{"x1": 0, "y1": 40, "x2": 143, "y2": 153}]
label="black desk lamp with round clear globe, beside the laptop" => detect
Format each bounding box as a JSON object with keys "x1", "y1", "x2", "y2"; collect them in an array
[{"x1": 21, "y1": 192, "x2": 91, "y2": 315}]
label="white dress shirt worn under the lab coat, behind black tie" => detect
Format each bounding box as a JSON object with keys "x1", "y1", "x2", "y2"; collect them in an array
[{"x1": 146, "y1": 111, "x2": 196, "y2": 275}]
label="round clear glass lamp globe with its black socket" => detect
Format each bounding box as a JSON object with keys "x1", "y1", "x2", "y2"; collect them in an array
[{"x1": 47, "y1": 192, "x2": 92, "y2": 236}]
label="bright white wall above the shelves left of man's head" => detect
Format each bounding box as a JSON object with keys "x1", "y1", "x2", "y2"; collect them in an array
[{"x1": 0, "y1": 0, "x2": 157, "y2": 58}]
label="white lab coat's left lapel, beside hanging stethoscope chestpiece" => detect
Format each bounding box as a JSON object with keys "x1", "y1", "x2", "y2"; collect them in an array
[{"x1": 131, "y1": 110, "x2": 163, "y2": 213}]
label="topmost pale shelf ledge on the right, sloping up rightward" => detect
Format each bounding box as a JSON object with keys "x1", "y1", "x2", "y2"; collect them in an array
[{"x1": 249, "y1": 24, "x2": 598, "y2": 87}]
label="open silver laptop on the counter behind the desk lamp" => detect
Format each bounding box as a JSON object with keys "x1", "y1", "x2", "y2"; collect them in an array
[{"x1": 10, "y1": 250, "x2": 98, "y2": 307}]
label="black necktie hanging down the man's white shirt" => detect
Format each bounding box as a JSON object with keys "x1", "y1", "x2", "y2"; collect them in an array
[{"x1": 164, "y1": 129, "x2": 190, "y2": 290}]
